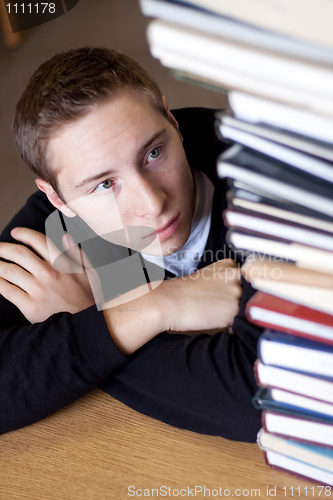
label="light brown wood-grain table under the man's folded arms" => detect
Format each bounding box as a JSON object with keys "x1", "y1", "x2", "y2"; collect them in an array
[{"x1": 0, "y1": 390, "x2": 322, "y2": 500}]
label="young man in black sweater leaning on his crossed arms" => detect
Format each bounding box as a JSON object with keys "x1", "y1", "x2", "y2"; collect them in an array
[{"x1": 0, "y1": 48, "x2": 260, "y2": 441}]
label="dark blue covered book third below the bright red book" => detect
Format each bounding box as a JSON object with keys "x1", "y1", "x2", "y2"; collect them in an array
[{"x1": 253, "y1": 387, "x2": 333, "y2": 425}]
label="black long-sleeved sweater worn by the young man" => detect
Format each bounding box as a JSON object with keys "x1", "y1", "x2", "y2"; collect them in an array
[{"x1": 0, "y1": 108, "x2": 261, "y2": 441}]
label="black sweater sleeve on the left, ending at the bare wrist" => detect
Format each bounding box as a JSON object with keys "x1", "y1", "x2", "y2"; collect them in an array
[{"x1": 0, "y1": 194, "x2": 127, "y2": 433}]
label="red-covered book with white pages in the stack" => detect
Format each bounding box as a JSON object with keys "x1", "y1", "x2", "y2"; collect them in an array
[{"x1": 246, "y1": 292, "x2": 333, "y2": 345}]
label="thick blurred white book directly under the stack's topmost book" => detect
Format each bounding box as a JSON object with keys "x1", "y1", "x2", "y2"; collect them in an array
[{"x1": 147, "y1": 20, "x2": 333, "y2": 115}]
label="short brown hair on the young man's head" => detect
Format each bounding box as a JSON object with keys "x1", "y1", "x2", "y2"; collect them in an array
[{"x1": 12, "y1": 47, "x2": 169, "y2": 194}]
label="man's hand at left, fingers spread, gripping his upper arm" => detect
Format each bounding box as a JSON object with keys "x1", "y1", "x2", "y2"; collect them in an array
[{"x1": 0, "y1": 228, "x2": 95, "y2": 323}]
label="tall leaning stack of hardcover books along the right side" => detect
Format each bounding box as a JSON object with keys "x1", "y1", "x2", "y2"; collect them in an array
[{"x1": 140, "y1": 0, "x2": 333, "y2": 485}]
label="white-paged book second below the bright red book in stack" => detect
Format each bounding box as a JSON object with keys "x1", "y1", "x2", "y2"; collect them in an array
[{"x1": 255, "y1": 360, "x2": 333, "y2": 404}]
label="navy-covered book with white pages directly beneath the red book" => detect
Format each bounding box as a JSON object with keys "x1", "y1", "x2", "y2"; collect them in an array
[{"x1": 258, "y1": 329, "x2": 333, "y2": 379}]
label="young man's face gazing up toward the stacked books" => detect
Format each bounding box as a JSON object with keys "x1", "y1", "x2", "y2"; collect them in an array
[{"x1": 48, "y1": 91, "x2": 195, "y2": 255}]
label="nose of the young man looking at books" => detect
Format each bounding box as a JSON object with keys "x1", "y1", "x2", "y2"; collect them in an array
[{"x1": 132, "y1": 178, "x2": 167, "y2": 217}]
